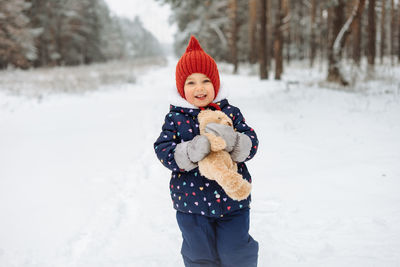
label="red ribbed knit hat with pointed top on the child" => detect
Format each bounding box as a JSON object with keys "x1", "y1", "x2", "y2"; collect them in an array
[{"x1": 175, "y1": 35, "x2": 219, "y2": 99}]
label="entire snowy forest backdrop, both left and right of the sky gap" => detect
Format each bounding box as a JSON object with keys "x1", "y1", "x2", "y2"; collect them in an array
[{"x1": 0, "y1": 0, "x2": 400, "y2": 85}]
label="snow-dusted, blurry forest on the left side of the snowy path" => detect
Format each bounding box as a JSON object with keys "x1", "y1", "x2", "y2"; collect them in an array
[{"x1": 0, "y1": 0, "x2": 161, "y2": 69}]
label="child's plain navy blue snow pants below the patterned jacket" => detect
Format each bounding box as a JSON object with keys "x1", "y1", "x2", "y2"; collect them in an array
[{"x1": 176, "y1": 208, "x2": 258, "y2": 267}]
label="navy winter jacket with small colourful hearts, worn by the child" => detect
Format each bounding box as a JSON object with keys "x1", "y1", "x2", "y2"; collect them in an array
[{"x1": 154, "y1": 99, "x2": 258, "y2": 217}]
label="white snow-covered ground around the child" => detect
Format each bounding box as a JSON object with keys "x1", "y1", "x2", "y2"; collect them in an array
[{"x1": 0, "y1": 60, "x2": 400, "y2": 267}]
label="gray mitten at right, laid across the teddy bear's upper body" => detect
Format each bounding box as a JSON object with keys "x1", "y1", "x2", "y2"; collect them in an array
[{"x1": 205, "y1": 123, "x2": 252, "y2": 162}]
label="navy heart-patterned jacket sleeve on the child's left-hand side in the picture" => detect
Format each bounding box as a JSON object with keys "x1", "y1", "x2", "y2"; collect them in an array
[{"x1": 154, "y1": 113, "x2": 180, "y2": 171}]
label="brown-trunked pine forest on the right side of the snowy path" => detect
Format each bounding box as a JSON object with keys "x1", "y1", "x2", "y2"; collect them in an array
[{"x1": 158, "y1": 0, "x2": 400, "y2": 85}]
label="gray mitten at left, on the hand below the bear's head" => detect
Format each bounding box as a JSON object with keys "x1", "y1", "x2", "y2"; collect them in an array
[{"x1": 174, "y1": 135, "x2": 211, "y2": 171}]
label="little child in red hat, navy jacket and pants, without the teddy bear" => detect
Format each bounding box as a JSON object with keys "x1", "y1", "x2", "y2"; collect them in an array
[{"x1": 154, "y1": 36, "x2": 258, "y2": 267}]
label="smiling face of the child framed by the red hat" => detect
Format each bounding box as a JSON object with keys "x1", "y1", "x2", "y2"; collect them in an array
[{"x1": 183, "y1": 73, "x2": 215, "y2": 107}]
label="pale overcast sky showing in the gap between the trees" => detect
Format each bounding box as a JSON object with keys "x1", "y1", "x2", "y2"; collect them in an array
[{"x1": 106, "y1": 0, "x2": 176, "y2": 43}]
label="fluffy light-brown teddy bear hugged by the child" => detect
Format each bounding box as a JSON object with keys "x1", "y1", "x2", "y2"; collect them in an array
[{"x1": 197, "y1": 109, "x2": 251, "y2": 201}]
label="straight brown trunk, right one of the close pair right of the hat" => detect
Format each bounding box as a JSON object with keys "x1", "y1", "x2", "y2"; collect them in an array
[{"x1": 274, "y1": 0, "x2": 285, "y2": 80}]
